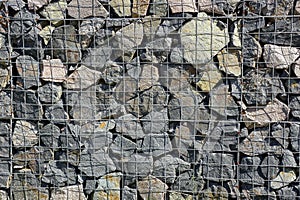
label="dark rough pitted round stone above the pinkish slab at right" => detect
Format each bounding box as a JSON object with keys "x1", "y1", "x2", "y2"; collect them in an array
[{"x1": 243, "y1": 70, "x2": 285, "y2": 106}]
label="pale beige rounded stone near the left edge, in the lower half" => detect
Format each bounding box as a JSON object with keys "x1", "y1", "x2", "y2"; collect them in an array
[{"x1": 12, "y1": 120, "x2": 39, "y2": 148}]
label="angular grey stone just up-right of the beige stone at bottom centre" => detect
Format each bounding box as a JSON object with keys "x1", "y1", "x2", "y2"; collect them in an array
[{"x1": 153, "y1": 155, "x2": 191, "y2": 184}]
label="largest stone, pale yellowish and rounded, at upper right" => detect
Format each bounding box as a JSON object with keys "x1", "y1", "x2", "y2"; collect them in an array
[{"x1": 180, "y1": 12, "x2": 229, "y2": 69}]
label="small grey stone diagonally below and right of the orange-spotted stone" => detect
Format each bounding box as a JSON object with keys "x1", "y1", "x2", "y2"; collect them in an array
[{"x1": 109, "y1": 135, "x2": 137, "y2": 157}]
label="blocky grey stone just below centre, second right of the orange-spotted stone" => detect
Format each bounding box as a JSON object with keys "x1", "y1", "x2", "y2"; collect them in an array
[{"x1": 141, "y1": 109, "x2": 169, "y2": 134}]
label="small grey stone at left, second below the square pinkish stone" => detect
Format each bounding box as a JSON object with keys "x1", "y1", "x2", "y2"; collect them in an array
[{"x1": 45, "y1": 101, "x2": 69, "y2": 124}]
